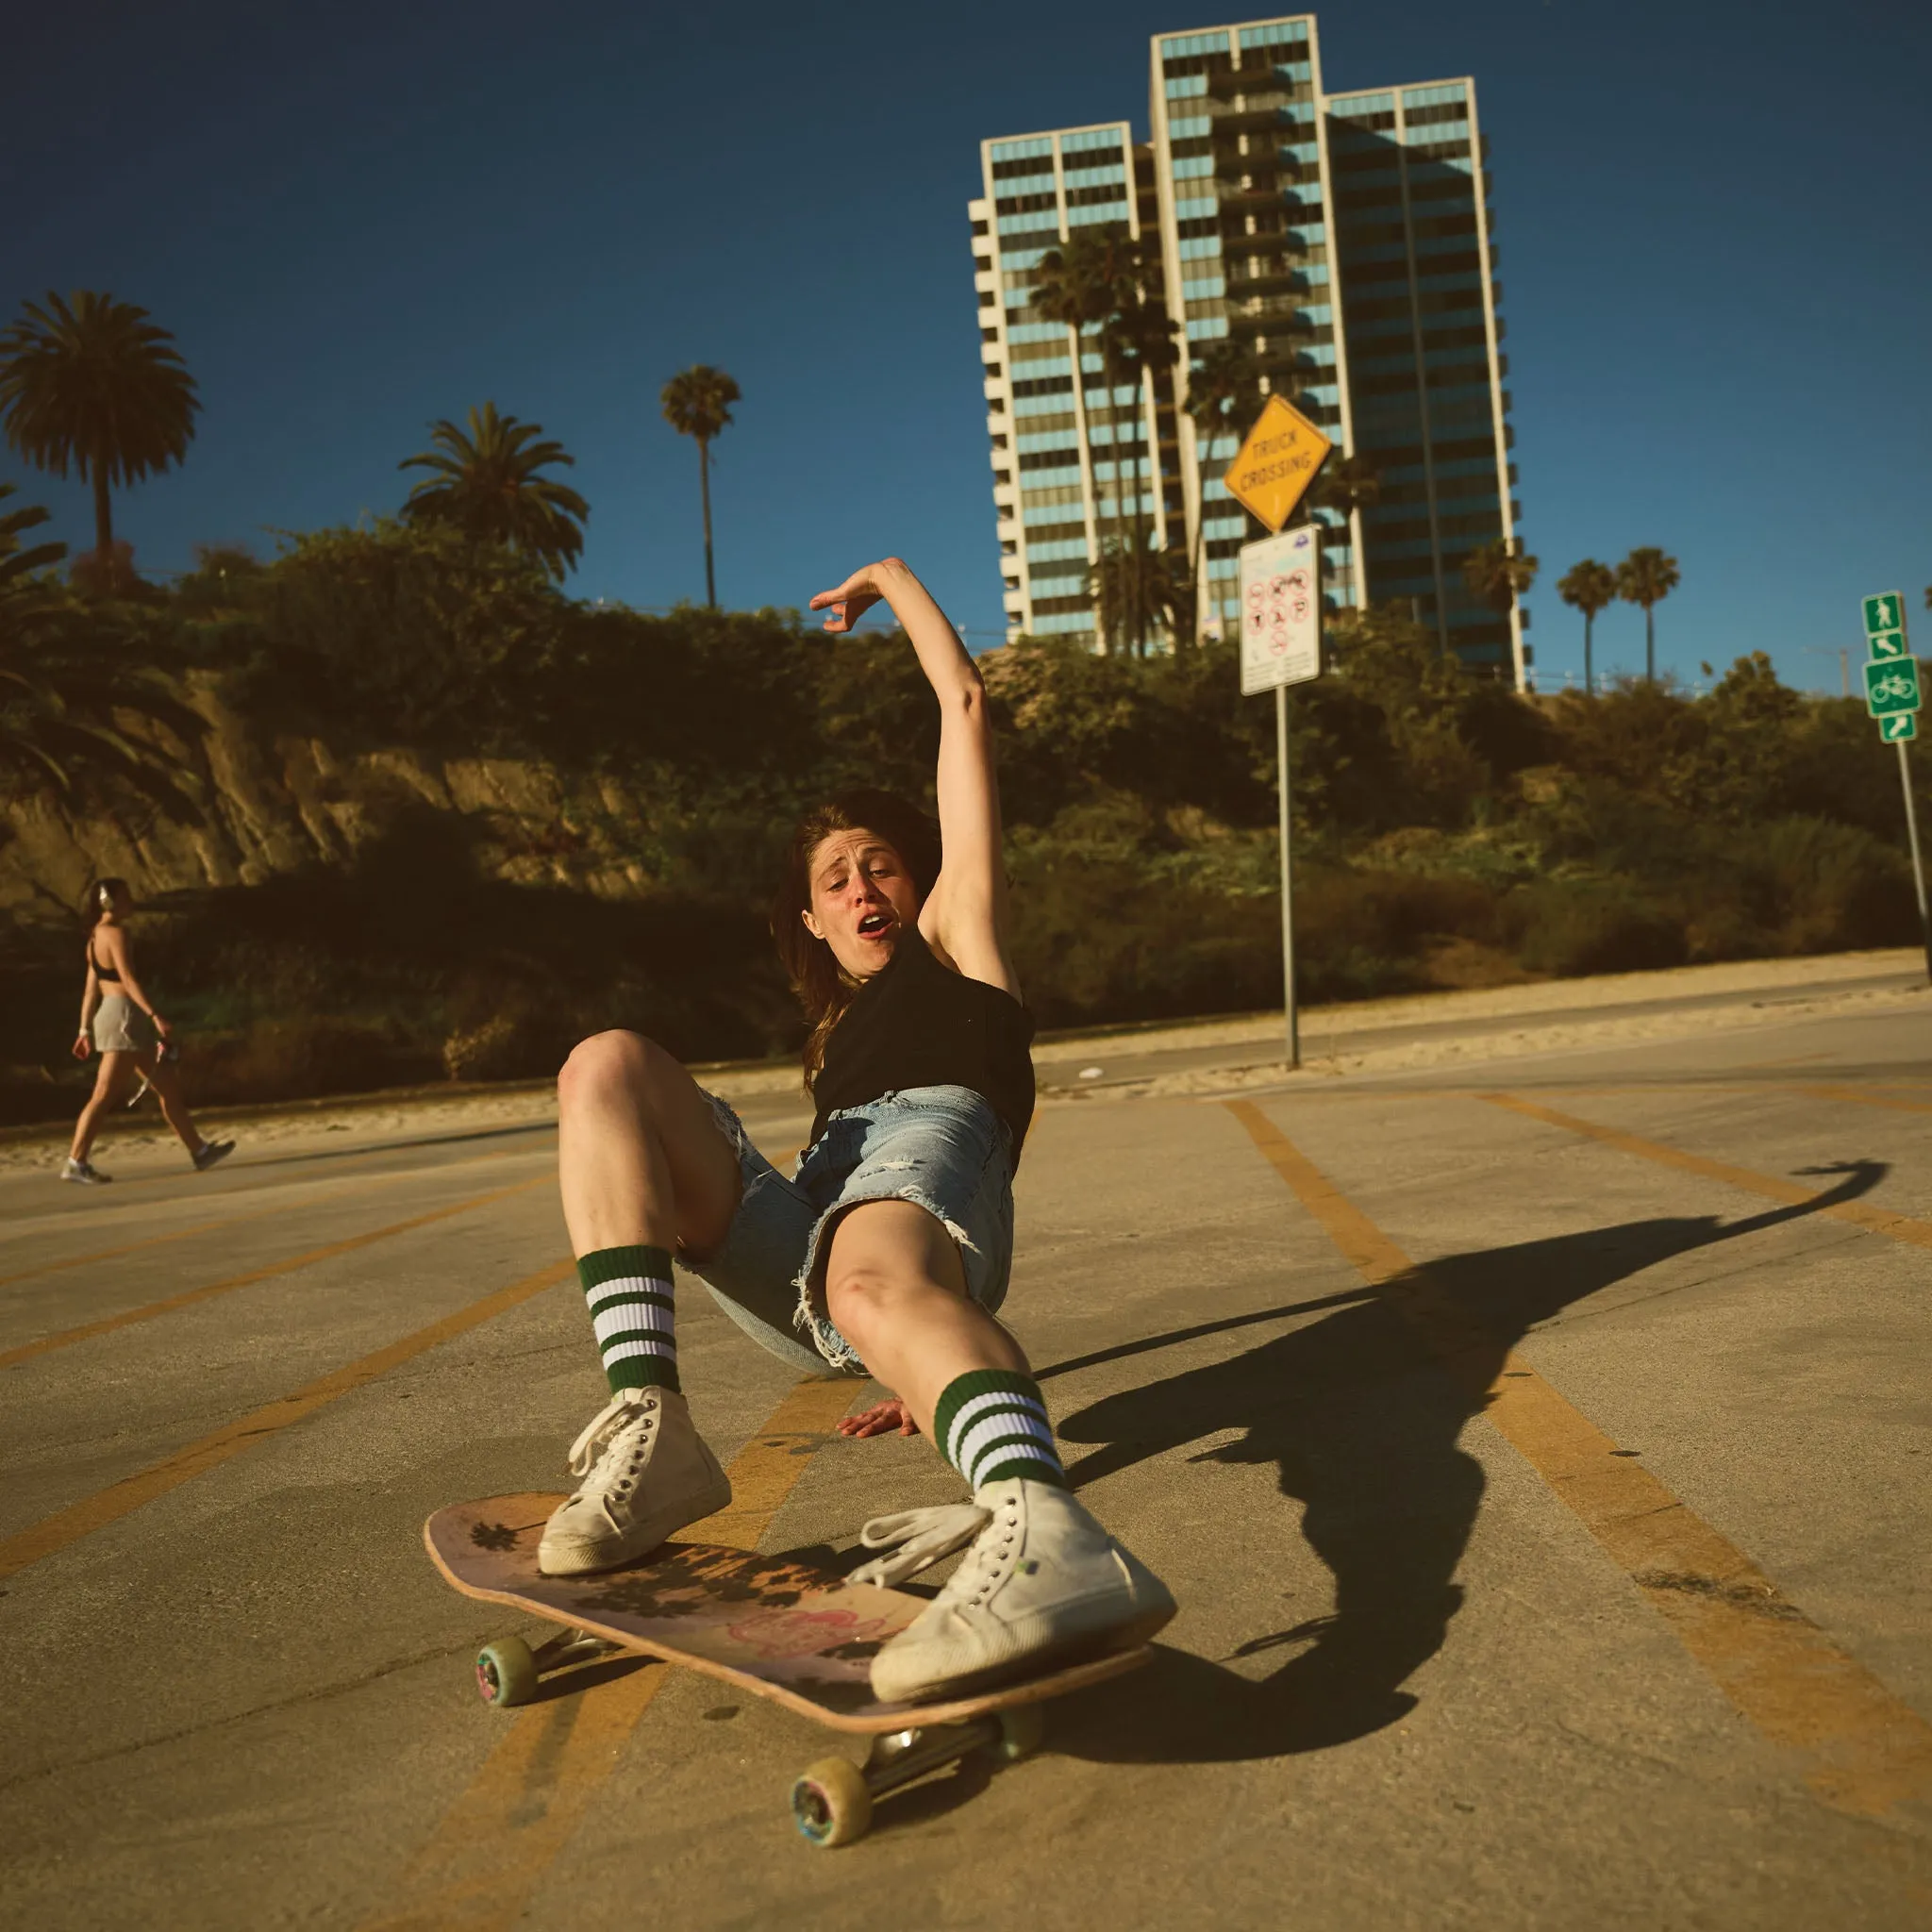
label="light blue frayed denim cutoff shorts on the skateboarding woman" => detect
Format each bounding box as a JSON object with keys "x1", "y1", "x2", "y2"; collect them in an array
[{"x1": 678, "y1": 1086, "x2": 1012, "y2": 1375}]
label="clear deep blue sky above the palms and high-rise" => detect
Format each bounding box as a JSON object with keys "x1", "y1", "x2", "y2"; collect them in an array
[{"x1": 0, "y1": 0, "x2": 1932, "y2": 688}]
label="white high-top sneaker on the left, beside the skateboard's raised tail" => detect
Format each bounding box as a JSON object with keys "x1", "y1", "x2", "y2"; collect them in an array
[{"x1": 537, "y1": 1390, "x2": 730, "y2": 1576}]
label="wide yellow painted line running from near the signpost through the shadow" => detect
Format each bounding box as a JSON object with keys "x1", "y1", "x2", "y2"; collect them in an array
[{"x1": 1226, "y1": 1101, "x2": 1932, "y2": 1818}]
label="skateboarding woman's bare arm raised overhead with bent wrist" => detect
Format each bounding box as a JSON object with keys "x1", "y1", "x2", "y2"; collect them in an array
[{"x1": 811, "y1": 557, "x2": 1020, "y2": 997}]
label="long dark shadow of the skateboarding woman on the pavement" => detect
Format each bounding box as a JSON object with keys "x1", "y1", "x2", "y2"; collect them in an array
[{"x1": 1041, "y1": 1161, "x2": 1888, "y2": 1762}]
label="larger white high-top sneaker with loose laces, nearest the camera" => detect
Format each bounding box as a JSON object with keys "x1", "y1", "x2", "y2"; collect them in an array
[{"x1": 866, "y1": 1476, "x2": 1174, "y2": 1704}]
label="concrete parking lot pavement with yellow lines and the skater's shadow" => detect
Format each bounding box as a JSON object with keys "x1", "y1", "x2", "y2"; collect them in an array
[{"x1": 0, "y1": 1005, "x2": 1932, "y2": 1928}]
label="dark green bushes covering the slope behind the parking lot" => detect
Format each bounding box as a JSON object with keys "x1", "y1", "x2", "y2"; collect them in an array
[{"x1": 0, "y1": 552, "x2": 1932, "y2": 1117}]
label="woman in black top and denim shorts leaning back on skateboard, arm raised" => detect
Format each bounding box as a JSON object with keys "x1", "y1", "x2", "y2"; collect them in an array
[{"x1": 539, "y1": 558, "x2": 1174, "y2": 1700}]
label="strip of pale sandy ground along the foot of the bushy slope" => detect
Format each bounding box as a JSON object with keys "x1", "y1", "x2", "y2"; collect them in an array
[{"x1": 0, "y1": 947, "x2": 1932, "y2": 1171}]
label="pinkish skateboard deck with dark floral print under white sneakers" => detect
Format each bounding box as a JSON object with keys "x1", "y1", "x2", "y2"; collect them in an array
[{"x1": 424, "y1": 1493, "x2": 1154, "y2": 1735}]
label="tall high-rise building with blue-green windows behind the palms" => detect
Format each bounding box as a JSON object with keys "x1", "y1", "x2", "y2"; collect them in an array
[{"x1": 972, "y1": 13, "x2": 1528, "y2": 684}]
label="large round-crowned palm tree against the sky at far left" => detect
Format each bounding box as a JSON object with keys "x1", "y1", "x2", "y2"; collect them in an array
[{"x1": 0, "y1": 288, "x2": 201, "y2": 568}]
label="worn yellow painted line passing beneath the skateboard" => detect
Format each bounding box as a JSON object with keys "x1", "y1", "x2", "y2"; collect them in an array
[{"x1": 361, "y1": 1377, "x2": 854, "y2": 1932}]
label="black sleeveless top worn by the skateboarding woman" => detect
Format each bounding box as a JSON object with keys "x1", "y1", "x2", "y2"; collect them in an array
[{"x1": 811, "y1": 925, "x2": 1034, "y2": 1165}]
